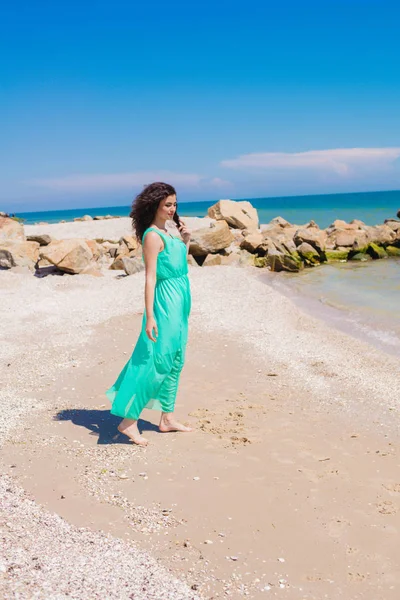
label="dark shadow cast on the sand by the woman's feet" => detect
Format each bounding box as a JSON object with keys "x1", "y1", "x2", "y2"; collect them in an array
[{"x1": 54, "y1": 408, "x2": 158, "y2": 444}]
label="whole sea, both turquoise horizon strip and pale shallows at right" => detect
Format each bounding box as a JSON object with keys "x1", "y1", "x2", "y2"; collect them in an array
[{"x1": 17, "y1": 191, "x2": 400, "y2": 357}]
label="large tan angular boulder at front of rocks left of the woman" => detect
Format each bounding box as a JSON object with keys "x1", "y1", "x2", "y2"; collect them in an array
[{"x1": 40, "y1": 238, "x2": 93, "y2": 273}]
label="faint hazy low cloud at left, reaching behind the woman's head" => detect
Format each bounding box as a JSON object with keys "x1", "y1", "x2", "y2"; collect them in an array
[{"x1": 29, "y1": 171, "x2": 201, "y2": 192}]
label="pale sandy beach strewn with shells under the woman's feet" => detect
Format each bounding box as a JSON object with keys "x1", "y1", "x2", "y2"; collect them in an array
[{"x1": 0, "y1": 219, "x2": 400, "y2": 600}]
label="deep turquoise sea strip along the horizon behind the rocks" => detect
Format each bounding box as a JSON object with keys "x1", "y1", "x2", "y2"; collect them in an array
[{"x1": 13, "y1": 191, "x2": 400, "y2": 227}]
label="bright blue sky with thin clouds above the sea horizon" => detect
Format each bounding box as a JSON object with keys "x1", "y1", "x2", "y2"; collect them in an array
[{"x1": 0, "y1": 0, "x2": 400, "y2": 211}]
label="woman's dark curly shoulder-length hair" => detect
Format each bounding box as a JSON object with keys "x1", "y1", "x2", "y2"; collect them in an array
[{"x1": 129, "y1": 181, "x2": 180, "y2": 244}]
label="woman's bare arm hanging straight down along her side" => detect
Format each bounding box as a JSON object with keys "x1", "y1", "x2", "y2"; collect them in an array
[{"x1": 143, "y1": 231, "x2": 163, "y2": 342}]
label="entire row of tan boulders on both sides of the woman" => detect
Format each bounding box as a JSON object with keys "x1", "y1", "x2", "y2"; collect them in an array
[{"x1": 0, "y1": 200, "x2": 400, "y2": 276}]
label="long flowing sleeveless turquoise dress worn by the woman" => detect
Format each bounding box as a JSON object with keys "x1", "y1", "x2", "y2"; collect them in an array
[{"x1": 106, "y1": 227, "x2": 191, "y2": 419}]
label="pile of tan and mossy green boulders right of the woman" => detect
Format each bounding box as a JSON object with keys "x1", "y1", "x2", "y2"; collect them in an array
[{"x1": 184, "y1": 200, "x2": 400, "y2": 272}]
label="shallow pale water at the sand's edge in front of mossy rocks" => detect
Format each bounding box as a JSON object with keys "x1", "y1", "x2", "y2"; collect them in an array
[{"x1": 264, "y1": 258, "x2": 400, "y2": 356}]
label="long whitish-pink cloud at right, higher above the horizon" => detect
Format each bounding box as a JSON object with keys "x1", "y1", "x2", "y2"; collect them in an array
[{"x1": 221, "y1": 148, "x2": 400, "y2": 175}]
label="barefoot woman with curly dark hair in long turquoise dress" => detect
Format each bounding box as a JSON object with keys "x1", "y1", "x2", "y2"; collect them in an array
[{"x1": 106, "y1": 183, "x2": 192, "y2": 446}]
